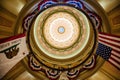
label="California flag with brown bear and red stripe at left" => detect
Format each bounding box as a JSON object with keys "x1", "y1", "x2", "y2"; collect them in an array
[{"x1": 0, "y1": 33, "x2": 29, "y2": 79}]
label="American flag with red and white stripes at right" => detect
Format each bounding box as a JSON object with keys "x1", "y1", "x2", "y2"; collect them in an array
[{"x1": 96, "y1": 33, "x2": 120, "y2": 70}]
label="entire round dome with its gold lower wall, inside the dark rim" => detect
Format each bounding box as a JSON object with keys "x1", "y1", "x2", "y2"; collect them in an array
[{"x1": 29, "y1": 5, "x2": 95, "y2": 69}]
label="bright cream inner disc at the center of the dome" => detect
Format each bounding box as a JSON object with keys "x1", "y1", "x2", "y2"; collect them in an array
[{"x1": 43, "y1": 12, "x2": 80, "y2": 49}]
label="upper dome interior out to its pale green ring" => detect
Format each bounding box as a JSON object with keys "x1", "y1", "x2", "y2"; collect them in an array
[{"x1": 32, "y1": 6, "x2": 93, "y2": 59}]
